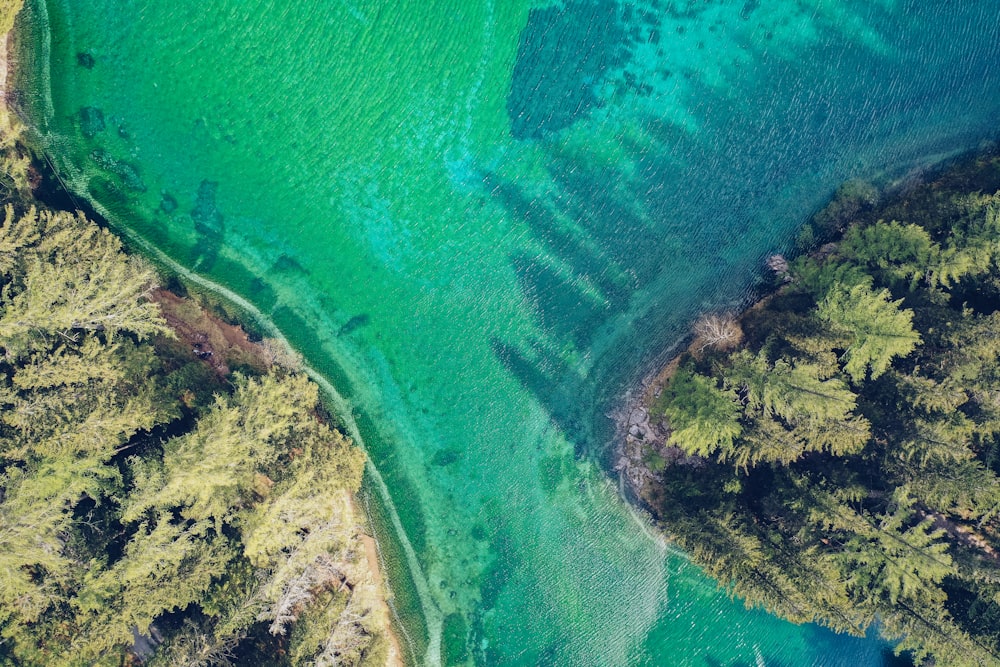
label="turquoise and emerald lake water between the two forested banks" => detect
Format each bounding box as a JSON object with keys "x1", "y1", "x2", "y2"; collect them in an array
[{"x1": 22, "y1": 0, "x2": 1000, "y2": 666}]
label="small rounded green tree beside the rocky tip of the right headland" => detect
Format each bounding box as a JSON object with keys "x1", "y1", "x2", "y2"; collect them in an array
[{"x1": 663, "y1": 369, "x2": 742, "y2": 456}]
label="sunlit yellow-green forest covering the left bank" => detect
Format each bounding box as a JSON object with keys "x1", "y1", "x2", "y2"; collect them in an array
[{"x1": 0, "y1": 129, "x2": 388, "y2": 666}]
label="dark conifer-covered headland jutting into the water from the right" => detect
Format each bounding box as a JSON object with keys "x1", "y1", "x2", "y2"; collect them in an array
[{"x1": 640, "y1": 158, "x2": 1000, "y2": 665}]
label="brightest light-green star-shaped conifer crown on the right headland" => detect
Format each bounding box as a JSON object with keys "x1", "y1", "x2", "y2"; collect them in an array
[{"x1": 817, "y1": 284, "x2": 920, "y2": 383}]
